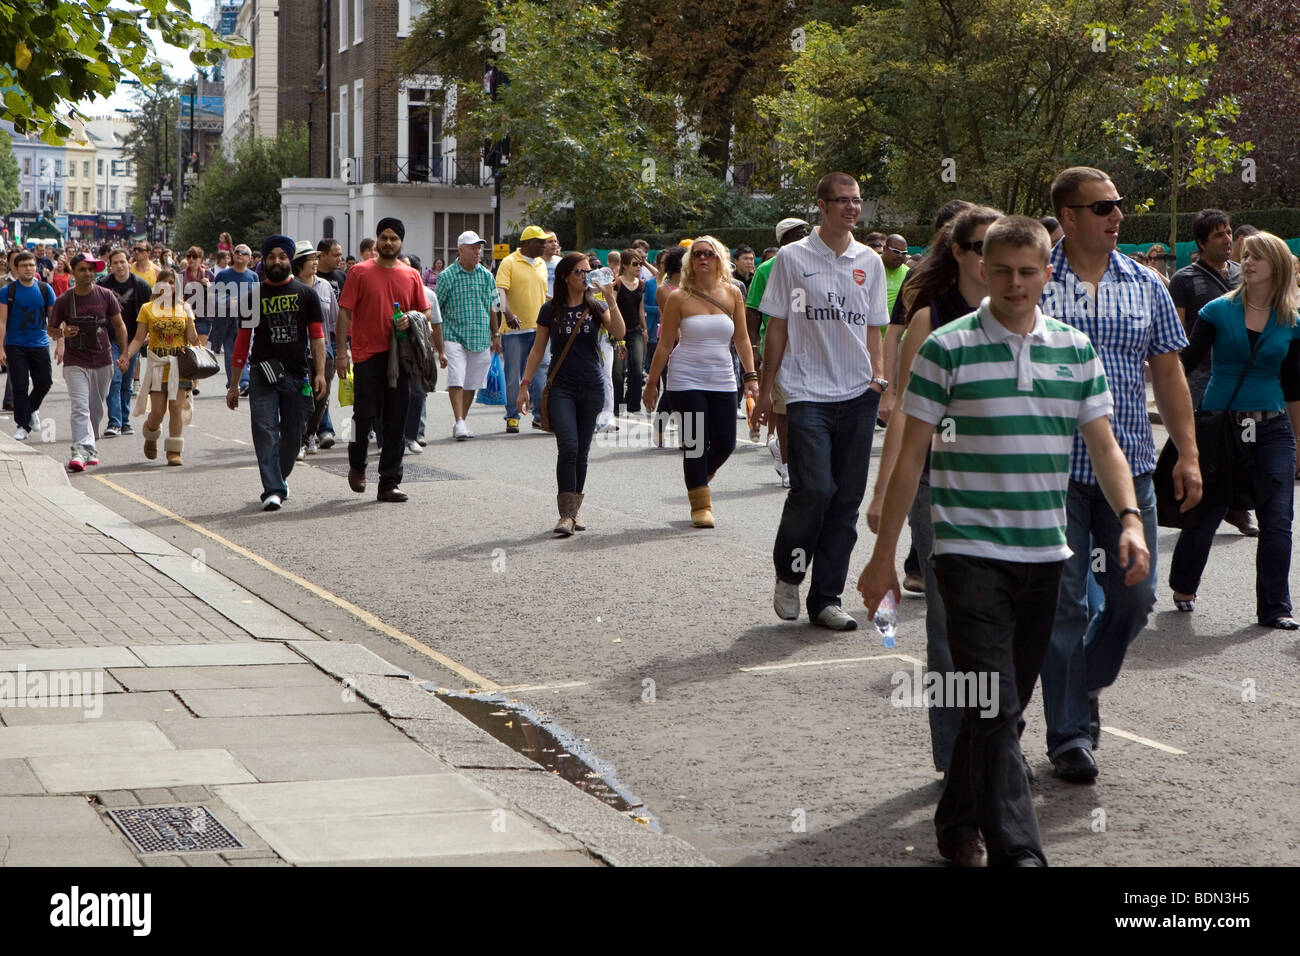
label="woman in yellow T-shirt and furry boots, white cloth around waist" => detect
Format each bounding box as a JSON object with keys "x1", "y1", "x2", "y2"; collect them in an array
[{"x1": 126, "y1": 268, "x2": 199, "y2": 464}]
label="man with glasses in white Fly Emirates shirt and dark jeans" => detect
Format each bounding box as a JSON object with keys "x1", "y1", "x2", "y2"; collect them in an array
[{"x1": 754, "y1": 173, "x2": 889, "y2": 631}]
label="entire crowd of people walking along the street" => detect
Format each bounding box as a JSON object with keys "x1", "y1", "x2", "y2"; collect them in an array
[{"x1": 0, "y1": 166, "x2": 1300, "y2": 866}]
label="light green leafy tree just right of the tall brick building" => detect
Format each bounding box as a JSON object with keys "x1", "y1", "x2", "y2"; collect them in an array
[{"x1": 399, "y1": 0, "x2": 718, "y2": 246}]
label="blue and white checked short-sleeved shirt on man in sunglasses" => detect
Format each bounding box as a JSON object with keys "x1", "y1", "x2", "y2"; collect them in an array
[{"x1": 1039, "y1": 241, "x2": 1187, "y2": 485}]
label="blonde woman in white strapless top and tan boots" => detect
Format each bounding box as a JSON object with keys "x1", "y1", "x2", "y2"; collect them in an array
[{"x1": 642, "y1": 235, "x2": 758, "y2": 528}]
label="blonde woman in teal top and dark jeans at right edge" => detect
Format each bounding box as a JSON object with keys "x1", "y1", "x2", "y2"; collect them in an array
[{"x1": 1169, "y1": 233, "x2": 1300, "y2": 631}]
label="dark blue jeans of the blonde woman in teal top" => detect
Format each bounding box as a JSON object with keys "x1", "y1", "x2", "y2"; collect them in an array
[{"x1": 1169, "y1": 415, "x2": 1296, "y2": 624}]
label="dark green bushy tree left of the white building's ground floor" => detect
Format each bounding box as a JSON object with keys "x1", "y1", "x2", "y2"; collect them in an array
[{"x1": 176, "y1": 125, "x2": 307, "y2": 248}]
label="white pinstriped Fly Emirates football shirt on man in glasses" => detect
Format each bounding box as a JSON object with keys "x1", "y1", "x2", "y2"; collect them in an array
[{"x1": 759, "y1": 226, "x2": 889, "y2": 402}]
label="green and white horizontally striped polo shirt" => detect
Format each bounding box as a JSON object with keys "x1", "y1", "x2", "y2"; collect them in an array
[{"x1": 902, "y1": 299, "x2": 1112, "y2": 563}]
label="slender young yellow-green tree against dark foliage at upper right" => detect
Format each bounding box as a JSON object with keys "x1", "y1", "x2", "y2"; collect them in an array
[{"x1": 1102, "y1": 0, "x2": 1255, "y2": 248}]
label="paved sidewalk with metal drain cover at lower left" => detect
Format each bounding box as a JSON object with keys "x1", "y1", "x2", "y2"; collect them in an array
[{"x1": 0, "y1": 423, "x2": 709, "y2": 866}]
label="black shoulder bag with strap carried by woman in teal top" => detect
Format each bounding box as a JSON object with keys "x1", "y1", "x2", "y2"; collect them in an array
[{"x1": 1152, "y1": 325, "x2": 1265, "y2": 529}]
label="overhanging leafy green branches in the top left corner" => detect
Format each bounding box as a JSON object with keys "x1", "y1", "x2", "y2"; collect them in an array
[{"x1": 0, "y1": 0, "x2": 252, "y2": 144}]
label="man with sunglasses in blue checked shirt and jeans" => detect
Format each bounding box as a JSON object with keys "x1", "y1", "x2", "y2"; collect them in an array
[{"x1": 1039, "y1": 166, "x2": 1201, "y2": 783}]
